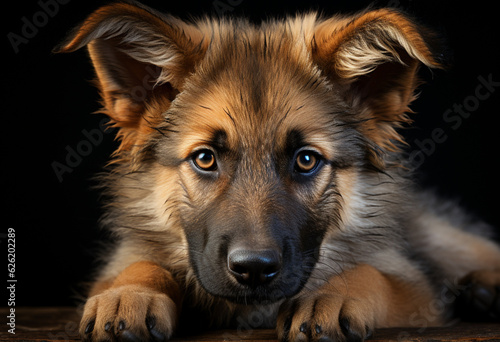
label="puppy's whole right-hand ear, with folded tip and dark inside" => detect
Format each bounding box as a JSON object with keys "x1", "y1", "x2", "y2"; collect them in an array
[{"x1": 312, "y1": 9, "x2": 440, "y2": 166}]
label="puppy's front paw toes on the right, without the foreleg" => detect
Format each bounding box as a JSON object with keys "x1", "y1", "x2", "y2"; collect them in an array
[{"x1": 277, "y1": 291, "x2": 376, "y2": 342}]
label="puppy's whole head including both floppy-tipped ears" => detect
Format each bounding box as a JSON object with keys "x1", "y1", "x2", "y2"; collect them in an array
[{"x1": 58, "y1": 3, "x2": 438, "y2": 303}]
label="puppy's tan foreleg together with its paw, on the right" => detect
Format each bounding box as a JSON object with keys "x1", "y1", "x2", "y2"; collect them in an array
[{"x1": 278, "y1": 265, "x2": 441, "y2": 341}]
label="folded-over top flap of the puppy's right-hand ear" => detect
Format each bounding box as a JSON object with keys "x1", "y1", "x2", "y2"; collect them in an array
[{"x1": 314, "y1": 9, "x2": 439, "y2": 79}]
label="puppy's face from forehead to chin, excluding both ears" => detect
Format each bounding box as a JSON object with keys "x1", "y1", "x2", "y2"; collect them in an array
[{"x1": 156, "y1": 39, "x2": 363, "y2": 302}]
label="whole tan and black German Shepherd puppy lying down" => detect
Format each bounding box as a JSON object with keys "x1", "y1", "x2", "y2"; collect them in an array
[{"x1": 55, "y1": 2, "x2": 500, "y2": 341}]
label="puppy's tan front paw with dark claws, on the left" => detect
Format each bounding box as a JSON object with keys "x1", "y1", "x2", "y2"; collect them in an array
[{"x1": 80, "y1": 285, "x2": 177, "y2": 341}]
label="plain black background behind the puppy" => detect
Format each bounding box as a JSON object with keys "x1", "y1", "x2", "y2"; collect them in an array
[{"x1": 4, "y1": 0, "x2": 500, "y2": 306}]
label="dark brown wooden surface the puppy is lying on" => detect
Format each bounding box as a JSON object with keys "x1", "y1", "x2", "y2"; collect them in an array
[{"x1": 0, "y1": 308, "x2": 500, "y2": 342}]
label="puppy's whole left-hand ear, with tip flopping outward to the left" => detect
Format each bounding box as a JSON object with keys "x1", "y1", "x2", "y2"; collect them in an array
[{"x1": 54, "y1": 2, "x2": 204, "y2": 152}]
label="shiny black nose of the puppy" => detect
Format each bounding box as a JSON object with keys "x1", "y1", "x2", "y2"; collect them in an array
[{"x1": 227, "y1": 249, "x2": 281, "y2": 287}]
